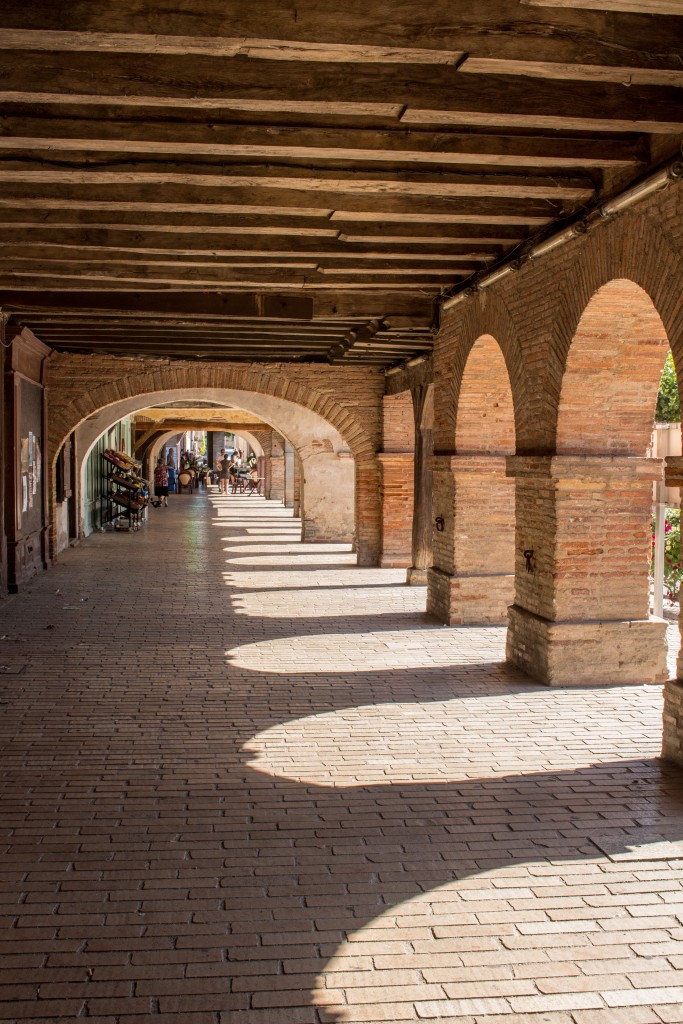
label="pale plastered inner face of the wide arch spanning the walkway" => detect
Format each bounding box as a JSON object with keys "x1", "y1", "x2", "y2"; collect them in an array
[{"x1": 62, "y1": 388, "x2": 355, "y2": 561}]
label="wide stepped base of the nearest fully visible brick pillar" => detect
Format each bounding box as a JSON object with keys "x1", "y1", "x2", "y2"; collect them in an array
[{"x1": 507, "y1": 604, "x2": 668, "y2": 686}]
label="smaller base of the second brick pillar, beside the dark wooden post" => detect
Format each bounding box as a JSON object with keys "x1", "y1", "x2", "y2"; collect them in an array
[{"x1": 427, "y1": 568, "x2": 515, "y2": 626}]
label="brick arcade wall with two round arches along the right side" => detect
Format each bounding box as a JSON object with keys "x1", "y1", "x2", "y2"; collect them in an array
[{"x1": 429, "y1": 184, "x2": 683, "y2": 682}]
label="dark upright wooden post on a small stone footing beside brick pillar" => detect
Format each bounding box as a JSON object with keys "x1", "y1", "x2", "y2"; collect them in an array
[{"x1": 405, "y1": 385, "x2": 434, "y2": 587}]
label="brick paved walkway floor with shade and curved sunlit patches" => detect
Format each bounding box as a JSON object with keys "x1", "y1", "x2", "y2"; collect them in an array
[{"x1": 0, "y1": 496, "x2": 683, "y2": 1024}]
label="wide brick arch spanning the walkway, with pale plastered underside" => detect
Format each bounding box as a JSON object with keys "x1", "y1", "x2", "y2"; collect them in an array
[{"x1": 49, "y1": 355, "x2": 379, "y2": 565}]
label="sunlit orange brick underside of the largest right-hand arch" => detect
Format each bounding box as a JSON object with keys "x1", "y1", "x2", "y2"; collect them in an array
[{"x1": 556, "y1": 279, "x2": 669, "y2": 457}]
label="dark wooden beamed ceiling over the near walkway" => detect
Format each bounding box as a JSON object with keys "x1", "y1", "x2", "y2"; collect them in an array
[{"x1": 0, "y1": 0, "x2": 683, "y2": 366}]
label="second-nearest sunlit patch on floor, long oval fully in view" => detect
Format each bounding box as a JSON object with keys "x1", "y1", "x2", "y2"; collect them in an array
[{"x1": 244, "y1": 684, "x2": 660, "y2": 797}]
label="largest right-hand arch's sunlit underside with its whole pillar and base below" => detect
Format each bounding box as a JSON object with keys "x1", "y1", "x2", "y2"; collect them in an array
[{"x1": 509, "y1": 279, "x2": 669, "y2": 685}]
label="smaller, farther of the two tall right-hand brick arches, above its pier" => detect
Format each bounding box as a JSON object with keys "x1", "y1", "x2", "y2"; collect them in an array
[{"x1": 436, "y1": 294, "x2": 531, "y2": 454}]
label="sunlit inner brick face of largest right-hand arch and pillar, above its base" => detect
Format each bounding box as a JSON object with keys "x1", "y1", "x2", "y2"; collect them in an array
[{"x1": 556, "y1": 280, "x2": 669, "y2": 620}]
